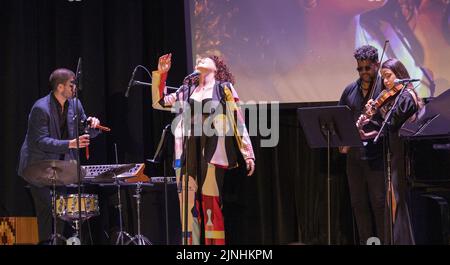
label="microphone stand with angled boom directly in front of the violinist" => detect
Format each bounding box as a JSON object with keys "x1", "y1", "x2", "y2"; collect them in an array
[{"x1": 373, "y1": 84, "x2": 407, "y2": 245}]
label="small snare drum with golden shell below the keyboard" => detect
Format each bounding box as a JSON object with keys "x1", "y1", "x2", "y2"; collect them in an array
[{"x1": 56, "y1": 194, "x2": 100, "y2": 221}]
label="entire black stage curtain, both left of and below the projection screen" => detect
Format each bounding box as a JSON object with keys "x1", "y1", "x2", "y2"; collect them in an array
[{"x1": 0, "y1": 0, "x2": 354, "y2": 244}]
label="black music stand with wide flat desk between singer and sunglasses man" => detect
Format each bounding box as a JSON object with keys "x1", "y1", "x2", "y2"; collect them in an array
[{"x1": 297, "y1": 106, "x2": 362, "y2": 245}]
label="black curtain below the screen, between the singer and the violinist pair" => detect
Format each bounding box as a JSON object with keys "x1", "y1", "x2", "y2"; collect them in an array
[{"x1": 224, "y1": 108, "x2": 355, "y2": 244}]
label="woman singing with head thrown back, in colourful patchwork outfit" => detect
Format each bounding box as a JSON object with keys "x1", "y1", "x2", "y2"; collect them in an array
[{"x1": 152, "y1": 54, "x2": 255, "y2": 245}]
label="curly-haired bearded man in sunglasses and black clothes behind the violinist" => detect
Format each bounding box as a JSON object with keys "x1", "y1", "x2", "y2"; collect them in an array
[{"x1": 339, "y1": 45, "x2": 386, "y2": 244}]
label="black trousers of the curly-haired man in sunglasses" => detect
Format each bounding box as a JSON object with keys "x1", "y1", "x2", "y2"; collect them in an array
[{"x1": 347, "y1": 148, "x2": 386, "y2": 245}]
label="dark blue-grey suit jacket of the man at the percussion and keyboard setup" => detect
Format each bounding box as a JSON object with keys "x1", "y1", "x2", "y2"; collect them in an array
[{"x1": 17, "y1": 94, "x2": 99, "y2": 182}]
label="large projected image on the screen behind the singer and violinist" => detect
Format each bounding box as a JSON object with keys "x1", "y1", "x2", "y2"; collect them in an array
[{"x1": 190, "y1": 0, "x2": 450, "y2": 103}]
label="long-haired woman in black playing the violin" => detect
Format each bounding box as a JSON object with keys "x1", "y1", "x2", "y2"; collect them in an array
[{"x1": 357, "y1": 59, "x2": 422, "y2": 245}]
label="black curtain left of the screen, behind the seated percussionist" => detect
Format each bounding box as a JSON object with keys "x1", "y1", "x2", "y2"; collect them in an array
[{"x1": 0, "y1": 0, "x2": 193, "y2": 243}]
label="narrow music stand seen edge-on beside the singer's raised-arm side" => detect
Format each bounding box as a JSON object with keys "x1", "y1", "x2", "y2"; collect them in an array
[{"x1": 147, "y1": 124, "x2": 170, "y2": 245}]
